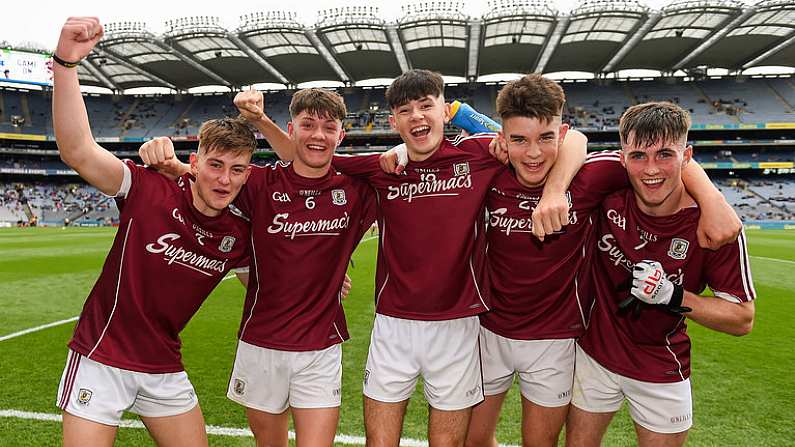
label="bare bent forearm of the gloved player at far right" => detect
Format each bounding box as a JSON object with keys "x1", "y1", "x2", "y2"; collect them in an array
[{"x1": 682, "y1": 291, "x2": 755, "y2": 336}]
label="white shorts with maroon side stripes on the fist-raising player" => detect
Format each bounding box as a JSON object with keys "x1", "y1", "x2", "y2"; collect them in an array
[{"x1": 55, "y1": 349, "x2": 199, "y2": 425}]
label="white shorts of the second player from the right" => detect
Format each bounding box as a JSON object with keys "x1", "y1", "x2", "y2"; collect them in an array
[{"x1": 480, "y1": 327, "x2": 575, "y2": 407}]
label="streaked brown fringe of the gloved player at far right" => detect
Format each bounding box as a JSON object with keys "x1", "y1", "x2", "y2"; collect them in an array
[{"x1": 618, "y1": 102, "x2": 690, "y2": 148}]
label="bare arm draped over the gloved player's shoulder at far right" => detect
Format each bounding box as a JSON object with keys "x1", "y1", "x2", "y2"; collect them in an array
[{"x1": 682, "y1": 160, "x2": 743, "y2": 250}]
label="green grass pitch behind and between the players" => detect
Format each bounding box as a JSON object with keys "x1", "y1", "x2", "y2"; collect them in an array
[{"x1": 0, "y1": 229, "x2": 795, "y2": 446}]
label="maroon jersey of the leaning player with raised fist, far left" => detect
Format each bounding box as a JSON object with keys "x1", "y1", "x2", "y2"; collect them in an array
[{"x1": 69, "y1": 160, "x2": 249, "y2": 373}]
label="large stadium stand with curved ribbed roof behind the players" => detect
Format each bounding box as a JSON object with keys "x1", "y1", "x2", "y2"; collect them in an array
[{"x1": 0, "y1": 0, "x2": 795, "y2": 229}]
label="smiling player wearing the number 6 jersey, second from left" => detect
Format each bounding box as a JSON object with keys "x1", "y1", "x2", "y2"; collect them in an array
[{"x1": 141, "y1": 88, "x2": 375, "y2": 447}]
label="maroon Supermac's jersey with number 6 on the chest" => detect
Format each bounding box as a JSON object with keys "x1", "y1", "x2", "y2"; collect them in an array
[{"x1": 235, "y1": 162, "x2": 375, "y2": 351}]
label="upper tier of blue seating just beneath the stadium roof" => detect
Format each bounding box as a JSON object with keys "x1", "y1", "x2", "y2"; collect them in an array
[{"x1": 0, "y1": 78, "x2": 795, "y2": 138}]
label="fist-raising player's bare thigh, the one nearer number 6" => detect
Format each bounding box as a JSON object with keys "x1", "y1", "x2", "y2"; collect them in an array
[{"x1": 141, "y1": 404, "x2": 207, "y2": 447}]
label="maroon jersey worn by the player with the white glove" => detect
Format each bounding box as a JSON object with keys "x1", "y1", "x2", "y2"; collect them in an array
[{"x1": 579, "y1": 189, "x2": 756, "y2": 383}]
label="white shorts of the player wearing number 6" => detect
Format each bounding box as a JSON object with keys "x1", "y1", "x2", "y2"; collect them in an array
[{"x1": 226, "y1": 340, "x2": 342, "y2": 414}]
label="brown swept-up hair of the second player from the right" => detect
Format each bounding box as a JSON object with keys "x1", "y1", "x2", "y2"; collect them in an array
[{"x1": 497, "y1": 74, "x2": 566, "y2": 123}]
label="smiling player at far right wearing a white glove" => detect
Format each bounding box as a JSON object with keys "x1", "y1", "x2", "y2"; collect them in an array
[{"x1": 566, "y1": 103, "x2": 756, "y2": 446}]
